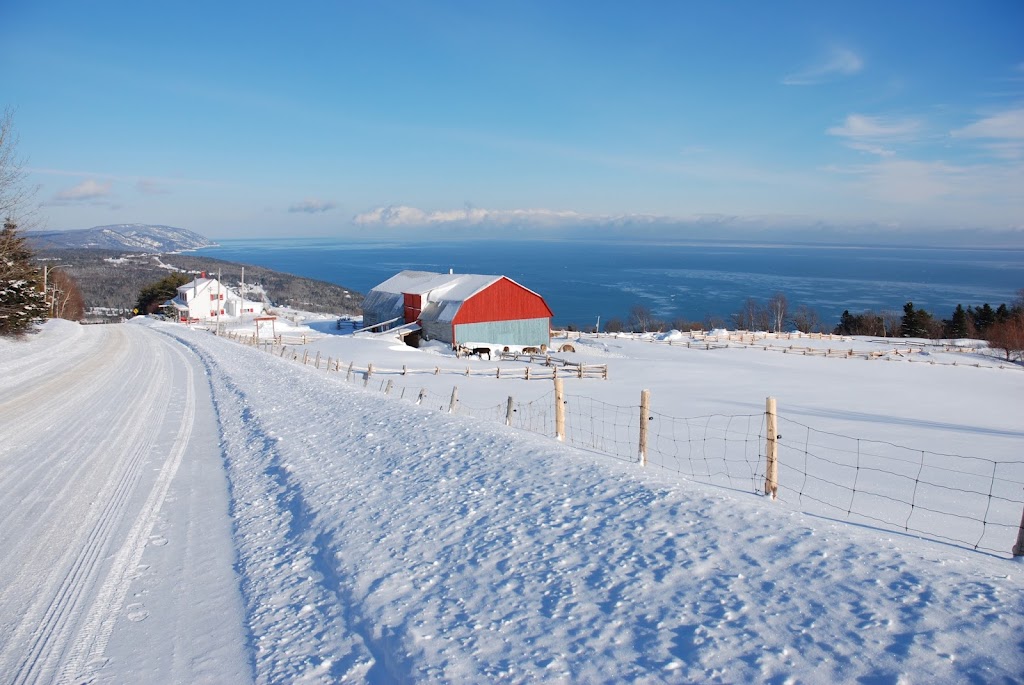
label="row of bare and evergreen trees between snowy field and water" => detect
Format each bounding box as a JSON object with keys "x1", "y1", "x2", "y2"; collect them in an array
[{"x1": 566, "y1": 290, "x2": 1024, "y2": 360}]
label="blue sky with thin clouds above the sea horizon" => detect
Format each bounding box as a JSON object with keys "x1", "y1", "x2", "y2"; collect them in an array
[{"x1": 0, "y1": 0, "x2": 1024, "y2": 245}]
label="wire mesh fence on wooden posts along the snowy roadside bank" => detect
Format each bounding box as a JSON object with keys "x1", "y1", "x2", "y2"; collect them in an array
[{"x1": 222, "y1": 327, "x2": 1024, "y2": 556}]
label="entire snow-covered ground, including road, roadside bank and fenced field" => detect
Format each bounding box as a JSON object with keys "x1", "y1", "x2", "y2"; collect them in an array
[{"x1": 0, "y1": 319, "x2": 1024, "y2": 683}]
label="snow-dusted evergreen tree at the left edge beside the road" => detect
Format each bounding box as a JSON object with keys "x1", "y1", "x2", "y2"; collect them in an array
[{"x1": 0, "y1": 220, "x2": 46, "y2": 336}]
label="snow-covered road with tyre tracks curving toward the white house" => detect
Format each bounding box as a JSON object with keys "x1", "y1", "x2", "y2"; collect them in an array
[{"x1": 0, "y1": 323, "x2": 250, "y2": 683}]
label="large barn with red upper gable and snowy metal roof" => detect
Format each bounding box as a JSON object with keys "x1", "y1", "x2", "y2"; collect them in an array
[{"x1": 362, "y1": 271, "x2": 552, "y2": 348}]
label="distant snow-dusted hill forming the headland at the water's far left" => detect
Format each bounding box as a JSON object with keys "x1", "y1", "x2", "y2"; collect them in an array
[{"x1": 25, "y1": 223, "x2": 216, "y2": 253}]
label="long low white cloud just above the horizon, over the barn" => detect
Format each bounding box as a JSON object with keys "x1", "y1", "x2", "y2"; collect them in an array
[{"x1": 352, "y1": 205, "x2": 596, "y2": 226}]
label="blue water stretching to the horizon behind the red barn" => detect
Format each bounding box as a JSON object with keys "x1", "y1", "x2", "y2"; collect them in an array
[{"x1": 200, "y1": 239, "x2": 1024, "y2": 327}]
